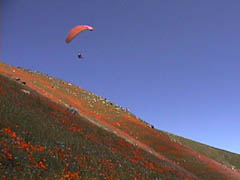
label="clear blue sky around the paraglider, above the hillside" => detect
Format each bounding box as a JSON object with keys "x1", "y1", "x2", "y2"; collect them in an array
[{"x1": 0, "y1": 0, "x2": 240, "y2": 153}]
